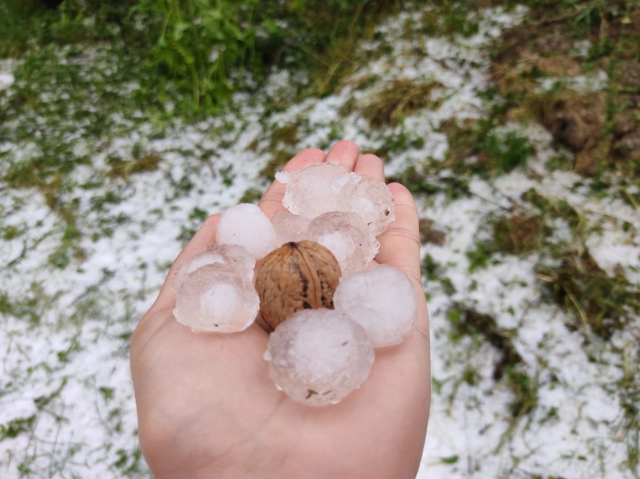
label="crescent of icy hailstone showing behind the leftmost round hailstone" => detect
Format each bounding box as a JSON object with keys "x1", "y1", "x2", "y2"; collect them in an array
[{"x1": 173, "y1": 244, "x2": 256, "y2": 291}]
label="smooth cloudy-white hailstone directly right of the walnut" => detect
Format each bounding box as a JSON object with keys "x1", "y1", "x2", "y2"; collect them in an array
[{"x1": 333, "y1": 265, "x2": 418, "y2": 348}]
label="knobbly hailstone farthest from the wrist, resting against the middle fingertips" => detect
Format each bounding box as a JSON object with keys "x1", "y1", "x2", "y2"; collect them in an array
[{"x1": 276, "y1": 163, "x2": 348, "y2": 218}]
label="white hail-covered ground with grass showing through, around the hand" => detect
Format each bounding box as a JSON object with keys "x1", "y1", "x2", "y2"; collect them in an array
[{"x1": 0, "y1": 3, "x2": 640, "y2": 479}]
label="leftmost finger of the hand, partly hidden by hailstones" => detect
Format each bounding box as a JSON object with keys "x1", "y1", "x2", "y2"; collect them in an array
[{"x1": 149, "y1": 215, "x2": 220, "y2": 313}]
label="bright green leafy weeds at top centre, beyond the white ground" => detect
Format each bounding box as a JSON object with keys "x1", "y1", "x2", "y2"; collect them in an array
[{"x1": 133, "y1": 0, "x2": 400, "y2": 111}]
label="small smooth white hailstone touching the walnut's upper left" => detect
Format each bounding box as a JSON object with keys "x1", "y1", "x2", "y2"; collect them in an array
[{"x1": 216, "y1": 203, "x2": 278, "y2": 259}]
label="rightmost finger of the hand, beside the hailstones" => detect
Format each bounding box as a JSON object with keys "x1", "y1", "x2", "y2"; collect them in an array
[{"x1": 376, "y1": 183, "x2": 422, "y2": 285}]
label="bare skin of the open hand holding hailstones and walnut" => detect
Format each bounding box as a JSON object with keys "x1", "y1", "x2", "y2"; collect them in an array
[{"x1": 131, "y1": 141, "x2": 431, "y2": 479}]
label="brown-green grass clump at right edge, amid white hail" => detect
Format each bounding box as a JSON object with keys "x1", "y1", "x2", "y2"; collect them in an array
[{"x1": 458, "y1": 190, "x2": 640, "y2": 340}]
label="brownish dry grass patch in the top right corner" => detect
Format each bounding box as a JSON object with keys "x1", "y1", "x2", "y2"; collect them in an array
[{"x1": 492, "y1": 0, "x2": 640, "y2": 177}]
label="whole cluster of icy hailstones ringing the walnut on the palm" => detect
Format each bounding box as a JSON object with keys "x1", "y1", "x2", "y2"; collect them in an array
[{"x1": 174, "y1": 163, "x2": 417, "y2": 405}]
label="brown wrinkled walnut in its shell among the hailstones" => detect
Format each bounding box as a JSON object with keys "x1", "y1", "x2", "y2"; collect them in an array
[{"x1": 256, "y1": 241, "x2": 342, "y2": 329}]
